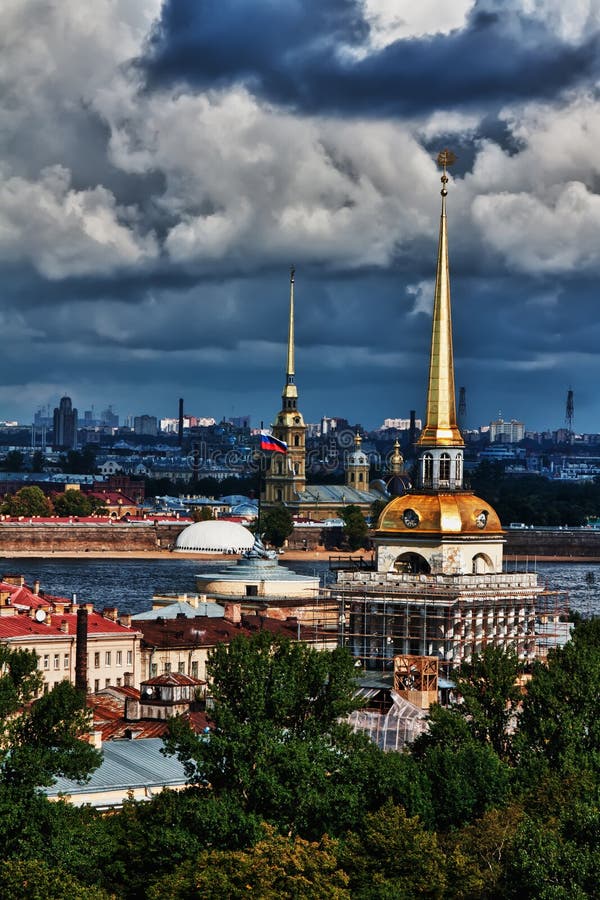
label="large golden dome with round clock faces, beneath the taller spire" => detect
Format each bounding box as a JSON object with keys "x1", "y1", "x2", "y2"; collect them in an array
[{"x1": 376, "y1": 491, "x2": 503, "y2": 537}]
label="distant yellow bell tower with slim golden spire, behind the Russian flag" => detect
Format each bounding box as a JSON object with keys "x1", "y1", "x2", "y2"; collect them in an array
[{"x1": 265, "y1": 266, "x2": 306, "y2": 503}]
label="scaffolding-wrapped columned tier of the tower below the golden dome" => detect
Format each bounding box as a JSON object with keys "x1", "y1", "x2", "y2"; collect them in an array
[{"x1": 329, "y1": 572, "x2": 570, "y2": 677}]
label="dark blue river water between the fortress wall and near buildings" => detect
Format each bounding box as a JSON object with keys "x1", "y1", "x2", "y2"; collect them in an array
[{"x1": 0, "y1": 557, "x2": 600, "y2": 615}]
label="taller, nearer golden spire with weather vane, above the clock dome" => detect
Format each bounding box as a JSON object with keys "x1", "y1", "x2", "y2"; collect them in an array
[{"x1": 419, "y1": 150, "x2": 464, "y2": 447}]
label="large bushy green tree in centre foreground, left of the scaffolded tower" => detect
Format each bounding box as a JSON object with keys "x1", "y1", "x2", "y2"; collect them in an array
[{"x1": 166, "y1": 632, "x2": 381, "y2": 837}]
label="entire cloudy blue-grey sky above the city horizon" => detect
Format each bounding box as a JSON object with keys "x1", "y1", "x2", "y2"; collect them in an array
[{"x1": 0, "y1": 0, "x2": 600, "y2": 432}]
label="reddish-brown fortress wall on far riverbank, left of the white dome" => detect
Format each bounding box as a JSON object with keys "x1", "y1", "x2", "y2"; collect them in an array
[{"x1": 0, "y1": 521, "x2": 187, "y2": 554}]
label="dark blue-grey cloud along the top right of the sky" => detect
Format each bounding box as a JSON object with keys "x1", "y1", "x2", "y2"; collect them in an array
[{"x1": 142, "y1": 0, "x2": 598, "y2": 116}]
